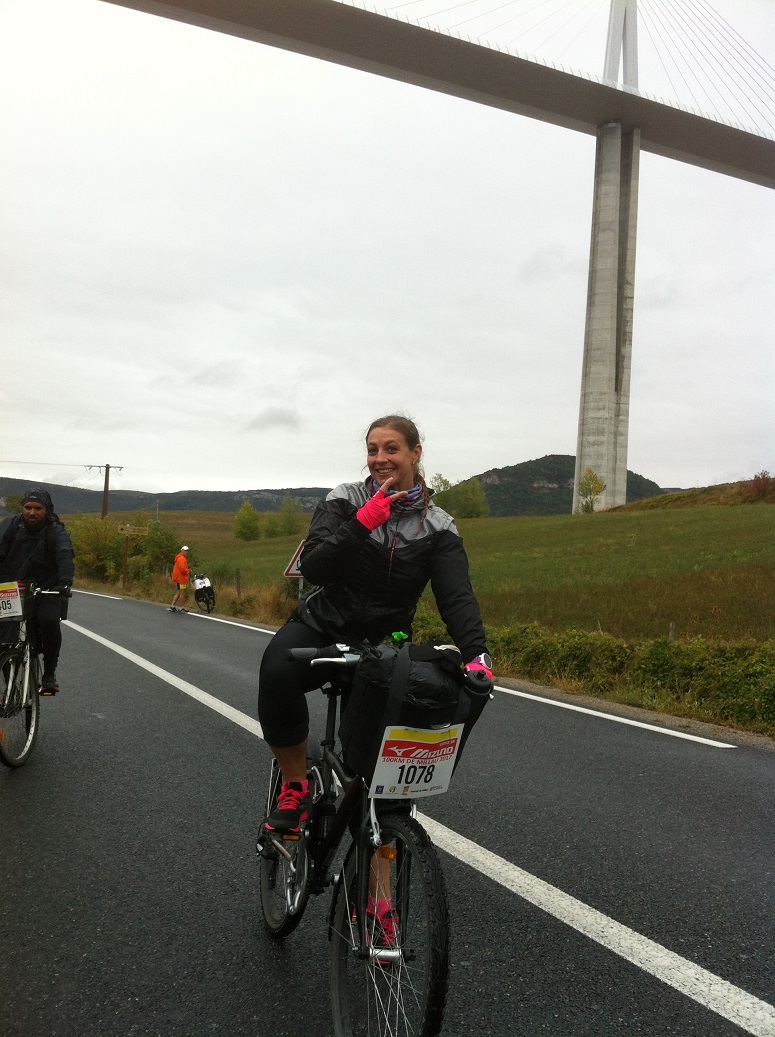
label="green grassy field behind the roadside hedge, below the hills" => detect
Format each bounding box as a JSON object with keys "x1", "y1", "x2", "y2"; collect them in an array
[{"x1": 110, "y1": 504, "x2": 775, "y2": 641}]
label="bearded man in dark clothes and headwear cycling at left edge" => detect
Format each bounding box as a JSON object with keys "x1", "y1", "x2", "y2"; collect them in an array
[{"x1": 0, "y1": 486, "x2": 74, "y2": 695}]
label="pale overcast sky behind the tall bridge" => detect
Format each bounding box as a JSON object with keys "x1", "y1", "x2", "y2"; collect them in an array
[{"x1": 0, "y1": 0, "x2": 775, "y2": 492}]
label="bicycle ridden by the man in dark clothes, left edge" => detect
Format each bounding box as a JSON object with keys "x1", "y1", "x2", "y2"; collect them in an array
[{"x1": 0, "y1": 583, "x2": 65, "y2": 767}]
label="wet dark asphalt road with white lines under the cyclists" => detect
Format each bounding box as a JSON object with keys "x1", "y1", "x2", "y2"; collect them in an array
[{"x1": 0, "y1": 594, "x2": 775, "y2": 1037}]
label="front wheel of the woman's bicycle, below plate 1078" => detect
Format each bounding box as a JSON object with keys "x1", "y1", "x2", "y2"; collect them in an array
[{"x1": 331, "y1": 814, "x2": 449, "y2": 1037}]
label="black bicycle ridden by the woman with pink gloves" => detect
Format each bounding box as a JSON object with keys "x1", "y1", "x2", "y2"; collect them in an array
[{"x1": 256, "y1": 645, "x2": 492, "y2": 1037}]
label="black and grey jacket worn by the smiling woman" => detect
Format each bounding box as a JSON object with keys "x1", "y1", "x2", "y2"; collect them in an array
[{"x1": 298, "y1": 480, "x2": 487, "y2": 662}]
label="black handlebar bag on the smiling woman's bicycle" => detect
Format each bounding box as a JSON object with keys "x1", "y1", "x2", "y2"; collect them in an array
[{"x1": 339, "y1": 642, "x2": 490, "y2": 781}]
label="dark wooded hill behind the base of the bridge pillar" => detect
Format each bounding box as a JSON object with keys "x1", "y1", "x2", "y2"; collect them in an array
[{"x1": 477, "y1": 454, "x2": 665, "y2": 517}]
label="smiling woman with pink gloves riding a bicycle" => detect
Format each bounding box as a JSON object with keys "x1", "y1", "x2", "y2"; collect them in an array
[{"x1": 258, "y1": 415, "x2": 492, "y2": 832}]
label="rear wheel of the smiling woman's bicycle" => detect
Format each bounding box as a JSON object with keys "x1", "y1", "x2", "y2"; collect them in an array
[{"x1": 258, "y1": 760, "x2": 320, "y2": 940}]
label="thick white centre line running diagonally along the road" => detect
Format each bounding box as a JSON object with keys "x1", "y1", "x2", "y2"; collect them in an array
[{"x1": 64, "y1": 619, "x2": 775, "y2": 1037}]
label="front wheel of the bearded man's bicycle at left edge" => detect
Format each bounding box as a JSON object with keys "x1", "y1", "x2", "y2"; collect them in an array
[{"x1": 0, "y1": 648, "x2": 40, "y2": 767}]
